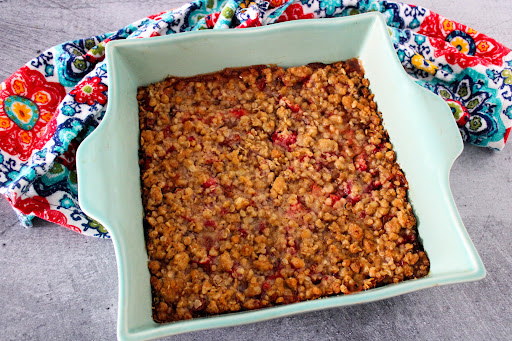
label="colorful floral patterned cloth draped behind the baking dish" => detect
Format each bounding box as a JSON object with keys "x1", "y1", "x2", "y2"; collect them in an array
[{"x1": 0, "y1": 0, "x2": 512, "y2": 238}]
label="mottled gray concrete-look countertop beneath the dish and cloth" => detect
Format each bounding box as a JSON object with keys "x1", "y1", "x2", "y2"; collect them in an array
[{"x1": 0, "y1": 0, "x2": 512, "y2": 340}]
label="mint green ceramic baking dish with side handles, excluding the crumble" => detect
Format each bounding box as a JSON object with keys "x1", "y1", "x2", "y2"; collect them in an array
[{"x1": 77, "y1": 13, "x2": 485, "y2": 340}]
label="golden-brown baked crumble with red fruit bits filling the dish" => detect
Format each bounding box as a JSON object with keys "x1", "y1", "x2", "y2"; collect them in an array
[{"x1": 137, "y1": 59, "x2": 429, "y2": 322}]
